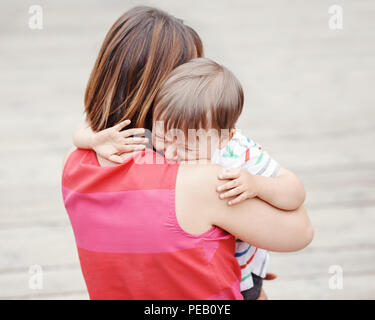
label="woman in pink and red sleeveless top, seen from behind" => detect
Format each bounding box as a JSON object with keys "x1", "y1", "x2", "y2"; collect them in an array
[{"x1": 62, "y1": 7, "x2": 312, "y2": 299}]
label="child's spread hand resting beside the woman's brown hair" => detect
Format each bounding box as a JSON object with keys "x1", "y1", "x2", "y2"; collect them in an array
[{"x1": 92, "y1": 120, "x2": 148, "y2": 163}]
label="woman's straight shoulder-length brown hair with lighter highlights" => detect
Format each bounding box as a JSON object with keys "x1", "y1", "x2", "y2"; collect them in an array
[{"x1": 84, "y1": 6, "x2": 203, "y2": 131}]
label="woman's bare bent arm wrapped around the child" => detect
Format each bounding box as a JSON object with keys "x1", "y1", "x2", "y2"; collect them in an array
[{"x1": 176, "y1": 164, "x2": 314, "y2": 252}]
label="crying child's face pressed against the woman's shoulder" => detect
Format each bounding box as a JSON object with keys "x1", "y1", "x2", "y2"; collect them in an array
[{"x1": 152, "y1": 121, "x2": 228, "y2": 161}]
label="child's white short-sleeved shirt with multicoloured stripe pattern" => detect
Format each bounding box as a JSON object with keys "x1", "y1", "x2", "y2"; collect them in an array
[{"x1": 211, "y1": 131, "x2": 280, "y2": 291}]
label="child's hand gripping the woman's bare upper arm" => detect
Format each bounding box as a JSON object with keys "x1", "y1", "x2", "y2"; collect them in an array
[{"x1": 217, "y1": 168, "x2": 258, "y2": 206}]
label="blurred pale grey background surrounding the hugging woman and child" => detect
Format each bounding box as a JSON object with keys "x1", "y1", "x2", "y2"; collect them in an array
[{"x1": 0, "y1": 0, "x2": 375, "y2": 299}]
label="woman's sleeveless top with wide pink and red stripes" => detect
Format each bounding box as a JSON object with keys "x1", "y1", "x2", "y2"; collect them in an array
[{"x1": 62, "y1": 149, "x2": 242, "y2": 300}]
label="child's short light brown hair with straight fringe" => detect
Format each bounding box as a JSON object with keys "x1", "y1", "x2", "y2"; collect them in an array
[{"x1": 153, "y1": 58, "x2": 244, "y2": 134}]
